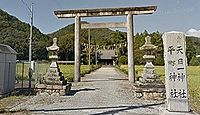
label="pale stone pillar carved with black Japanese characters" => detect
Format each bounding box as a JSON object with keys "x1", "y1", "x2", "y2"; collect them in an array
[{"x1": 161, "y1": 31, "x2": 195, "y2": 114}]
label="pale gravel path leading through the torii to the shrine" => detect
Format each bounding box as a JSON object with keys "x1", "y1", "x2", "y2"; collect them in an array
[{"x1": 11, "y1": 67, "x2": 163, "y2": 115}]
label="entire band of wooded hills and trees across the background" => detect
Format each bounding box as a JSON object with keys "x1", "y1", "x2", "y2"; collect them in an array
[{"x1": 0, "y1": 10, "x2": 200, "y2": 65}]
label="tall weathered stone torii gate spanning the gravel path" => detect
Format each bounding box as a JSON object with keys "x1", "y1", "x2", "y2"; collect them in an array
[{"x1": 54, "y1": 6, "x2": 157, "y2": 82}]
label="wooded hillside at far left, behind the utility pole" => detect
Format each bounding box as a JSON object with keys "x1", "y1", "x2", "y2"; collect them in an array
[{"x1": 0, "y1": 9, "x2": 49, "y2": 60}]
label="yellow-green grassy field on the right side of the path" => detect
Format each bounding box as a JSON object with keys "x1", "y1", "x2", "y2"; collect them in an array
[{"x1": 120, "y1": 65, "x2": 200, "y2": 113}]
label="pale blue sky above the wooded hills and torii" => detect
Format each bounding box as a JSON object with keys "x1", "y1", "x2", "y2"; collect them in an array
[{"x1": 0, "y1": 0, "x2": 200, "y2": 34}]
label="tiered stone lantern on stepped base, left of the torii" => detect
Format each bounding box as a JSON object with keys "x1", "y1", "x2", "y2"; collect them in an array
[{"x1": 36, "y1": 38, "x2": 71, "y2": 96}]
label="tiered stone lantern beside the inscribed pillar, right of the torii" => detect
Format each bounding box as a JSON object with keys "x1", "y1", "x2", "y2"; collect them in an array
[{"x1": 134, "y1": 36, "x2": 165, "y2": 99}]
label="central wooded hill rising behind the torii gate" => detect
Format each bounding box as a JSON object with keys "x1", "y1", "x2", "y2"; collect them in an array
[{"x1": 48, "y1": 22, "x2": 126, "y2": 60}]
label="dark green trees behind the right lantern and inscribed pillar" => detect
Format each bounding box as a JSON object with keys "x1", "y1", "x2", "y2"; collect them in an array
[{"x1": 134, "y1": 31, "x2": 200, "y2": 65}]
